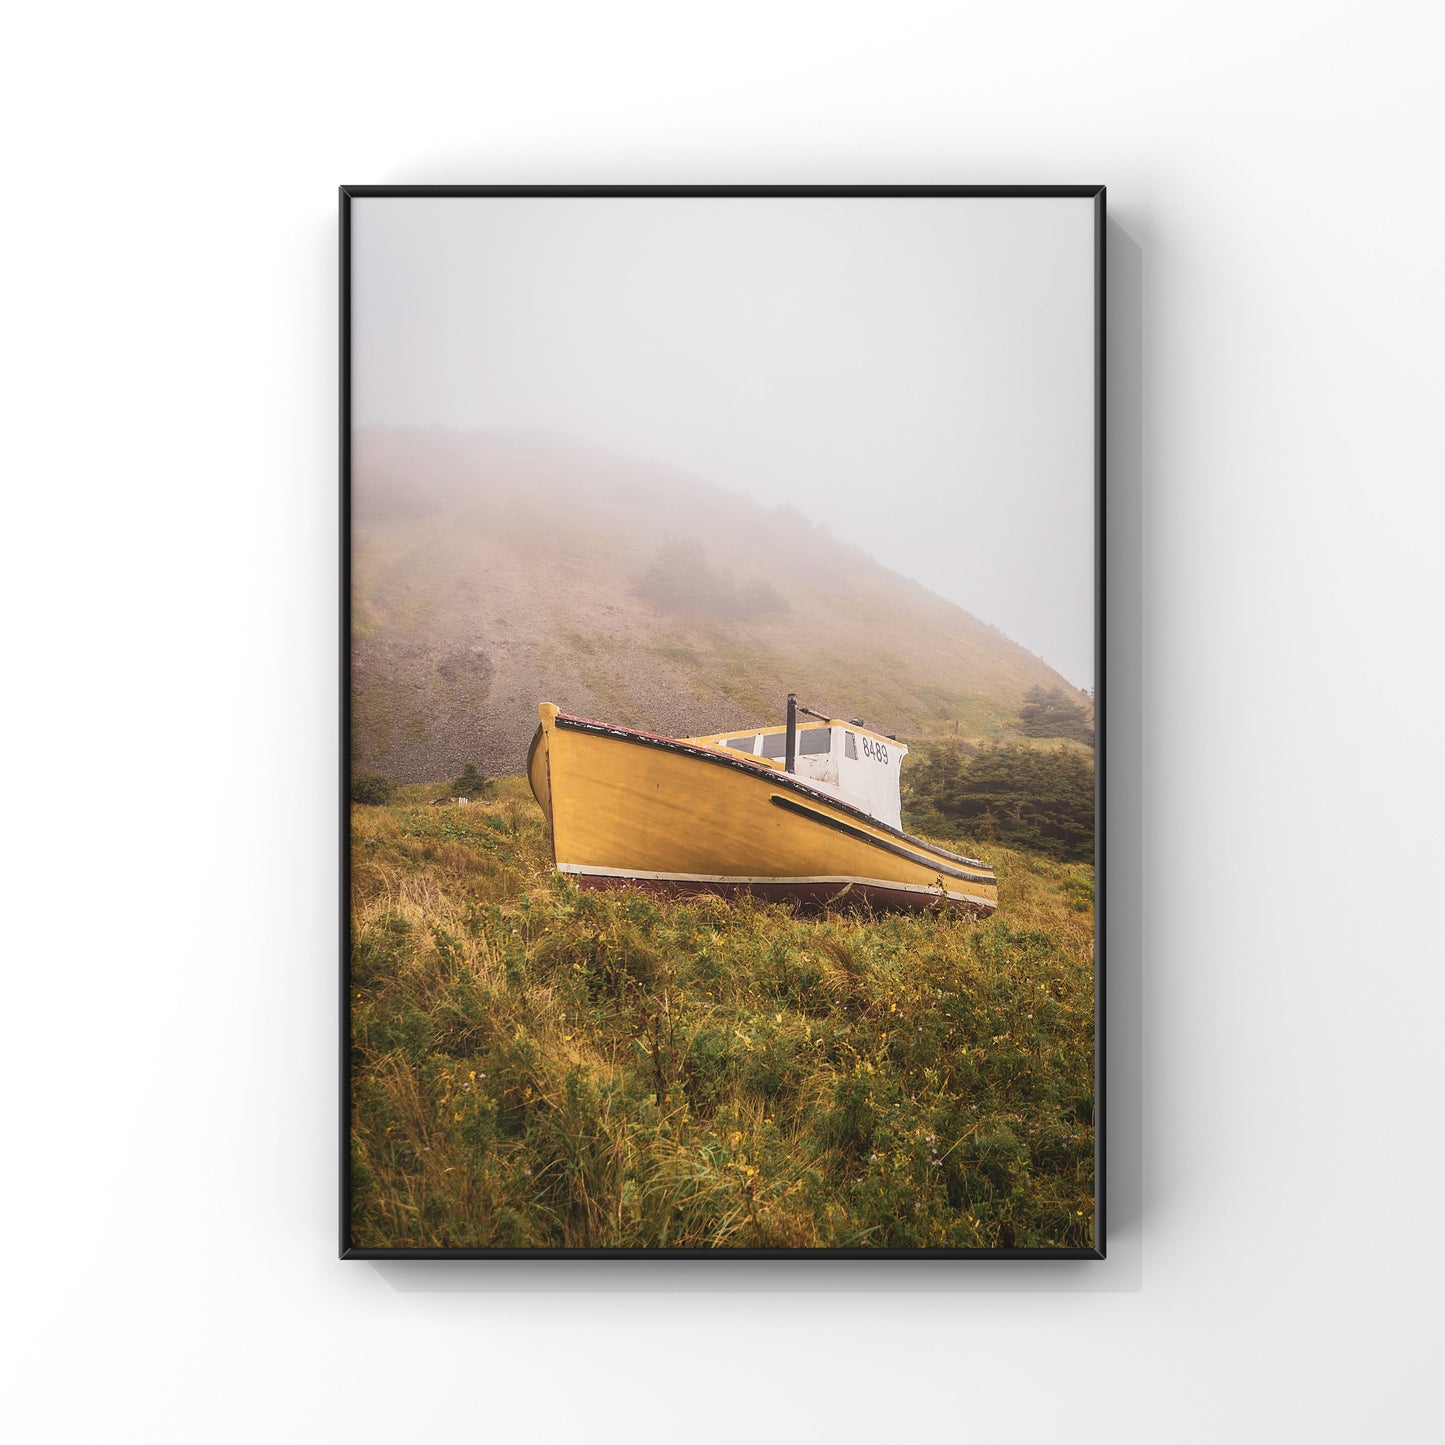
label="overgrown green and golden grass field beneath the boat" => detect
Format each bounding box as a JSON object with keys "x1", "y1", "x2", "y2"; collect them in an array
[{"x1": 351, "y1": 779, "x2": 1094, "y2": 1248}]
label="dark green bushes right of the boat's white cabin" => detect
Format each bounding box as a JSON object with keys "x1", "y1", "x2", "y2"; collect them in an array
[{"x1": 905, "y1": 738, "x2": 1094, "y2": 863}]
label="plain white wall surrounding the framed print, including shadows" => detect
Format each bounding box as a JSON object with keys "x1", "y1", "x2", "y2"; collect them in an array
[{"x1": 0, "y1": 0, "x2": 1445, "y2": 1441}]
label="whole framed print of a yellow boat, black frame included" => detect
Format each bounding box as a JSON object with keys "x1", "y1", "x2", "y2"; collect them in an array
[{"x1": 341, "y1": 186, "x2": 1104, "y2": 1259}]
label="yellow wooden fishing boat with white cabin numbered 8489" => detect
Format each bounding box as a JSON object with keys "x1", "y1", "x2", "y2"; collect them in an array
[{"x1": 527, "y1": 696, "x2": 998, "y2": 915}]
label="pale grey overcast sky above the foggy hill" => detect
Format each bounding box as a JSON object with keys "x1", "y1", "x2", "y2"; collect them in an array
[{"x1": 353, "y1": 198, "x2": 1094, "y2": 688}]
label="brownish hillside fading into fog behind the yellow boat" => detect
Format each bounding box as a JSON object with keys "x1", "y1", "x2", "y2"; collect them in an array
[{"x1": 351, "y1": 428, "x2": 1084, "y2": 782}]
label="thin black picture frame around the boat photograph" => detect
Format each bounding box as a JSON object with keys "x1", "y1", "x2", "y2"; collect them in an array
[{"x1": 338, "y1": 185, "x2": 1107, "y2": 1261}]
